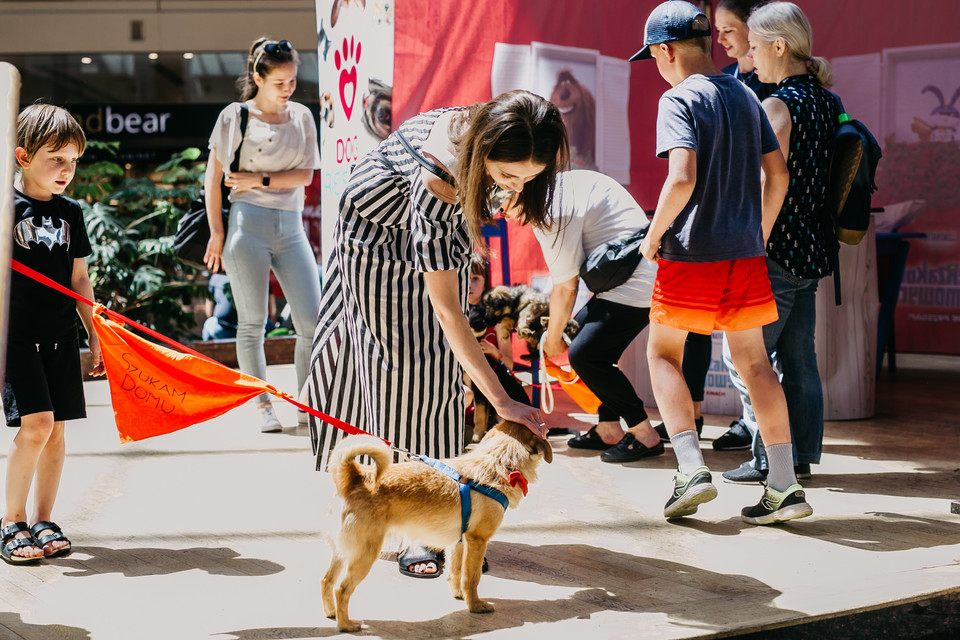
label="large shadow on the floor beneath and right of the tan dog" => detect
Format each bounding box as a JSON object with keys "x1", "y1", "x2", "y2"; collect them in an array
[{"x1": 274, "y1": 542, "x2": 798, "y2": 640}]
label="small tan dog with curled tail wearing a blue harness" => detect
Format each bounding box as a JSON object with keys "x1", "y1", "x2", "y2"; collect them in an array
[{"x1": 320, "y1": 422, "x2": 553, "y2": 631}]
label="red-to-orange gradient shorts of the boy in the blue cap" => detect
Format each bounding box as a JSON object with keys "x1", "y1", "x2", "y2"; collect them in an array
[{"x1": 650, "y1": 256, "x2": 777, "y2": 334}]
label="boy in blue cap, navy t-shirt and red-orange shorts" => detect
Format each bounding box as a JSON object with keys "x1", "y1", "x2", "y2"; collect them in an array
[{"x1": 631, "y1": 0, "x2": 813, "y2": 524}]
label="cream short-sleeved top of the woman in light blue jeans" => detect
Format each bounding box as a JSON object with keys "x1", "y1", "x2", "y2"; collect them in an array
[{"x1": 209, "y1": 101, "x2": 320, "y2": 211}]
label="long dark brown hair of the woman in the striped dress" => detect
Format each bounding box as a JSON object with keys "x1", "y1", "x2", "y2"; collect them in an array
[{"x1": 450, "y1": 90, "x2": 570, "y2": 247}]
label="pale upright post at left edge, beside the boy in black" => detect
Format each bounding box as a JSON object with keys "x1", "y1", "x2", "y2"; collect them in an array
[{"x1": 0, "y1": 62, "x2": 20, "y2": 380}]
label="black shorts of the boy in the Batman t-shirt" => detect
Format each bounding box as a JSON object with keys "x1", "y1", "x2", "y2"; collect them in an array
[{"x1": 3, "y1": 335, "x2": 87, "y2": 427}]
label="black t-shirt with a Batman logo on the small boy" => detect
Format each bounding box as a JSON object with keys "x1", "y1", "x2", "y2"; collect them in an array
[{"x1": 10, "y1": 191, "x2": 91, "y2": 341}]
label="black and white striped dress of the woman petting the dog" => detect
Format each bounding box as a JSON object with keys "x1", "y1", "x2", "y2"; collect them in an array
[{"x1": 307, "y1": 110, "x2": 472, "y2": 470}]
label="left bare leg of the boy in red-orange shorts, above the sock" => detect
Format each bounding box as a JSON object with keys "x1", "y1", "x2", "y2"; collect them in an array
[{"x1": 647, "y1": 323, "x2": 696, "y2": 436}]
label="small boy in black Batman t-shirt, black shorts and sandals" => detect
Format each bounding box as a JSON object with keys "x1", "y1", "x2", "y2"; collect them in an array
[{"x1": 0, "y1": 104, "x2": 103, "y2": 564}]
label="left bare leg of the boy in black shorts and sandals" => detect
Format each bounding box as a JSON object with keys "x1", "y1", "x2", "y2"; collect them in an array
[{"x1": 3, "y1": 411, "x2": 54, "y2": 558}]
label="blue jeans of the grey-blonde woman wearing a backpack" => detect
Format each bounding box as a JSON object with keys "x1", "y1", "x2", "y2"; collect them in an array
[{"x1": 723, "y1": 258, "x2": 823, "y2": 469}]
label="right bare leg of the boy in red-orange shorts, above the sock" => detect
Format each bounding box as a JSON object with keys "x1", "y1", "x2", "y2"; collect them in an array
[{"x1": 727, "y1": 327, "x2": 790, "y2": 446}]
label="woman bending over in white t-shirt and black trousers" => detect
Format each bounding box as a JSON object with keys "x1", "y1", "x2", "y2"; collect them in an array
[{"x1": 528, "y1": 171, "x2": 664, "y2": 462}]
